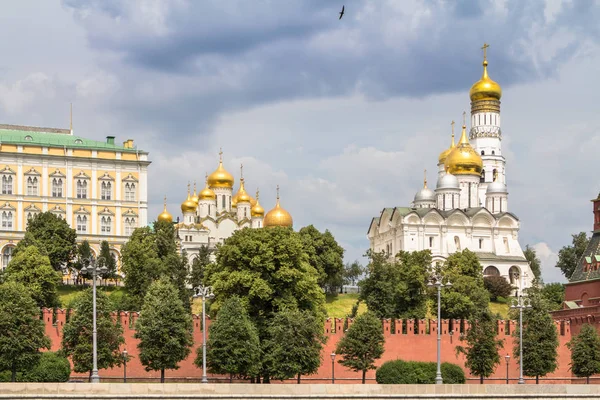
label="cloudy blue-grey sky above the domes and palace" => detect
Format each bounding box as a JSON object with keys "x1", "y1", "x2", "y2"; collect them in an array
[{"x1": 0, "y1": 0, "x2": 600, "y2": 282}]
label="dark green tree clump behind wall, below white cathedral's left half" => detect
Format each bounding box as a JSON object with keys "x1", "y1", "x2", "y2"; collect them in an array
[{"x1": 360, "y1": 250, "x2": 431, "y2": 318}]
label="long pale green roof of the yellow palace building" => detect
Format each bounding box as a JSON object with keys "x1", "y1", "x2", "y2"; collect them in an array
[{"x1": 0, "y1": 125, "x2": 139, "y2": 153}]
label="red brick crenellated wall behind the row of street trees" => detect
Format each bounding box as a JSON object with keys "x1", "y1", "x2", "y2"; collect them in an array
[{"x1": 43, "y1": 309, "x2": 571, "y2": 383}]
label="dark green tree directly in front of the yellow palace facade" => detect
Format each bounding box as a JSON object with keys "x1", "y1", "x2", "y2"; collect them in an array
[{"x1": 15, "y1": 211, "x2": 77, "y2": 271}]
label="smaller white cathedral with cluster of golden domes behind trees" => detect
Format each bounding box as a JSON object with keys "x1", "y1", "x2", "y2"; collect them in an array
[{"x1": 158, "y1": 152, "x2": 293, "y2": 261}]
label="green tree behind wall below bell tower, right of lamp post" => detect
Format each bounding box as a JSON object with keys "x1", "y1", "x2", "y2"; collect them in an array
[{"x1": 438, "y1": 249, "x2": 490, "y2": 319}]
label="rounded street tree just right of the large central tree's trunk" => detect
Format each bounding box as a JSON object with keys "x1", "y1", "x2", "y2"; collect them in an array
[{"x1": 265, "y1": 310, "x2": 325, "y2": 383}]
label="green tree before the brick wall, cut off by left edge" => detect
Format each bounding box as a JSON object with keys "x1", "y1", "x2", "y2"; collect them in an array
[{"x1": 0, "y1": 282, "x2": 50, "y2": 382}]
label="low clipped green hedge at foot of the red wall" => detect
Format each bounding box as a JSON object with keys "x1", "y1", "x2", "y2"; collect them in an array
[{"x1": 375, "y1": 360, "x2": 467, "y2": 385}]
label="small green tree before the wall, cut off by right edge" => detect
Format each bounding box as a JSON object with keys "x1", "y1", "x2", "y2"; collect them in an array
[{"x1": 567, "y1": 324, "x2": 600, "y2": 384}]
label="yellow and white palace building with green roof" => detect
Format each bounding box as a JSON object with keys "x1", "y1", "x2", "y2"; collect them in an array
[{"x1": 0, "y1": 125, "x2": 150, "y2": 269}]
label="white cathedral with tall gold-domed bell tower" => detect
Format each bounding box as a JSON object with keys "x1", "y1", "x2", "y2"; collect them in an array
[{"x1": 368, "y1": 45, "x2": 533, "y2": 289}]
